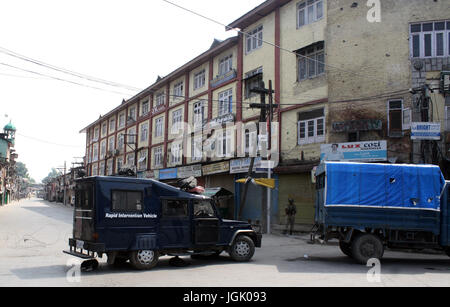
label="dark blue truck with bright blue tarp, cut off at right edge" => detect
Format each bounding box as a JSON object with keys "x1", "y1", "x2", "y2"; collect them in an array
[{"x1": 311, "y1": 162, "x2": 450, "y2": 264}]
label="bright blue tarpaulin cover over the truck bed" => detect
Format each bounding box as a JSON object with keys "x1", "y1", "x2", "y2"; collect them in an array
[{"x1": 325, "y1": 162, "x2": 445, "y2": 211}]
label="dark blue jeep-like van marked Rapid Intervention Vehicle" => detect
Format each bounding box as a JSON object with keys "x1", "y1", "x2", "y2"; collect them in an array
[{"x1": 64, "y1": 177, "x2": 261, "y2": 269}]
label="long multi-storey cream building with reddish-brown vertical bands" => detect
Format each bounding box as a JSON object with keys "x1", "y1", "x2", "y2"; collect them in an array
[{"x1": 83, "y1": 0, "x2": 450, "y2": 232}]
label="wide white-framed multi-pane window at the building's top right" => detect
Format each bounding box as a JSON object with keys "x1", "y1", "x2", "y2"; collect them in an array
[{"x1": 410, "y1": 21, "x2": 450, "y2": 58}]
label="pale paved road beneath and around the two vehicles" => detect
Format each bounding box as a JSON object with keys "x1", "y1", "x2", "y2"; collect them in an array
[{"x1": 0, "y1": 199, "x2": 450, "y2": 287}]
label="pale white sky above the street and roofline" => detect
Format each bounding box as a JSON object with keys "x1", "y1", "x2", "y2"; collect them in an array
[{"x1": 0, "y1": 0, "x2": 264, "y2": 182}]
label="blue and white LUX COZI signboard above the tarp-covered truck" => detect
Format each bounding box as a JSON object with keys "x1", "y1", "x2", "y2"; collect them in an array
[{"x1": 320, "y1": 141, "x2": 387, "y2": 162}]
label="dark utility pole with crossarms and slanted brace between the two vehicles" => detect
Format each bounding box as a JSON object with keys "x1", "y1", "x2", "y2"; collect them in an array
[{"x1": 239, "y1": 81, "x2": 278, "y2": 233}]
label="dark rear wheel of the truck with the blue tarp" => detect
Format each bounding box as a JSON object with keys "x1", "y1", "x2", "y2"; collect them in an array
[{"x1": 351, "y1": 234, "x2": 384, "y2": 264}]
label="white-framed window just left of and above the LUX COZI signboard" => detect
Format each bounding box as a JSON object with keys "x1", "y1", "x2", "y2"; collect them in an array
[{"x1": 297, "y1": 109, "x2": 325, "y2": 145}]
